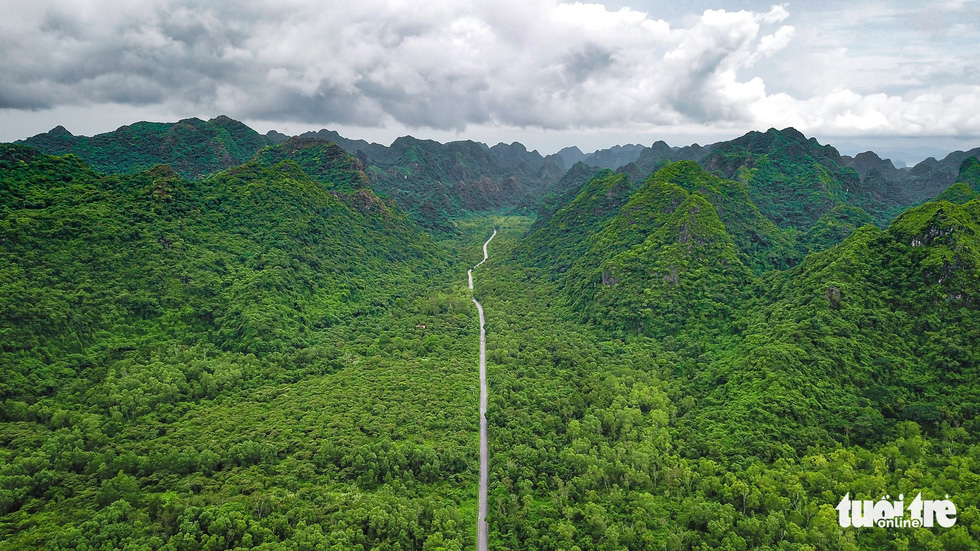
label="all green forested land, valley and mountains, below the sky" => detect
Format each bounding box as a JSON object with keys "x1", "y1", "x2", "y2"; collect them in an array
[{"x1": 0, "y1": 117, "x2": 980, "y2": 551}]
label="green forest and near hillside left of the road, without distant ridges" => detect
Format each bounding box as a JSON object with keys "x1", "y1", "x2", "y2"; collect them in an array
[{"x1": 0, "y1": 145, "x2": 488, "y2": 549}]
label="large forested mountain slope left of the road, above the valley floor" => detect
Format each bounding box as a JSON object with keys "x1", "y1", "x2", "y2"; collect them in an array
[{"x1": 0, "y1": 142, "x2": 442, "y2": 397}]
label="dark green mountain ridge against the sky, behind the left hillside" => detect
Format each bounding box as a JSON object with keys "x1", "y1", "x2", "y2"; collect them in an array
[{"x1": 19, "y1": 115, "x2": 270, "y2": 179}]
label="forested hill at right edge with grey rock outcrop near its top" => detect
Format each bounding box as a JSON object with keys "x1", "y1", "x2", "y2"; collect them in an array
[{"x1": 685, "y1": 196, "x2": 980, "y2": 457}]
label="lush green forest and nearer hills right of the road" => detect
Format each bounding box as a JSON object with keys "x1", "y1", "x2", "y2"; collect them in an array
[{"x1": 506, "y1": 141, "x2": 980, "y2": 549}]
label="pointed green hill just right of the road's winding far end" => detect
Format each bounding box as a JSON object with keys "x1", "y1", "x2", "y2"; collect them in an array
[{"x1": 521, "y1": 161, "x2": 799, "y2": 334}]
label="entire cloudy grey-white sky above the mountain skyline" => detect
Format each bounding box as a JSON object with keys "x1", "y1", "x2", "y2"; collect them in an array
[{"x1": 0, "y1": 0, "x2": 980, "y2": 162}]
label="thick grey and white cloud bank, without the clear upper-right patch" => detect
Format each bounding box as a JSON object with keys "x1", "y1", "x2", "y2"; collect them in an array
[{"x1": 0, "y1": 0, "x2": 980, "y2": 140}]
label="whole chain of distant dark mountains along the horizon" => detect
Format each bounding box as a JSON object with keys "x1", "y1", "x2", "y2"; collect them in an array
[{"x1": 17, "y1": 116, "x2": 980, "y2": 238}]
